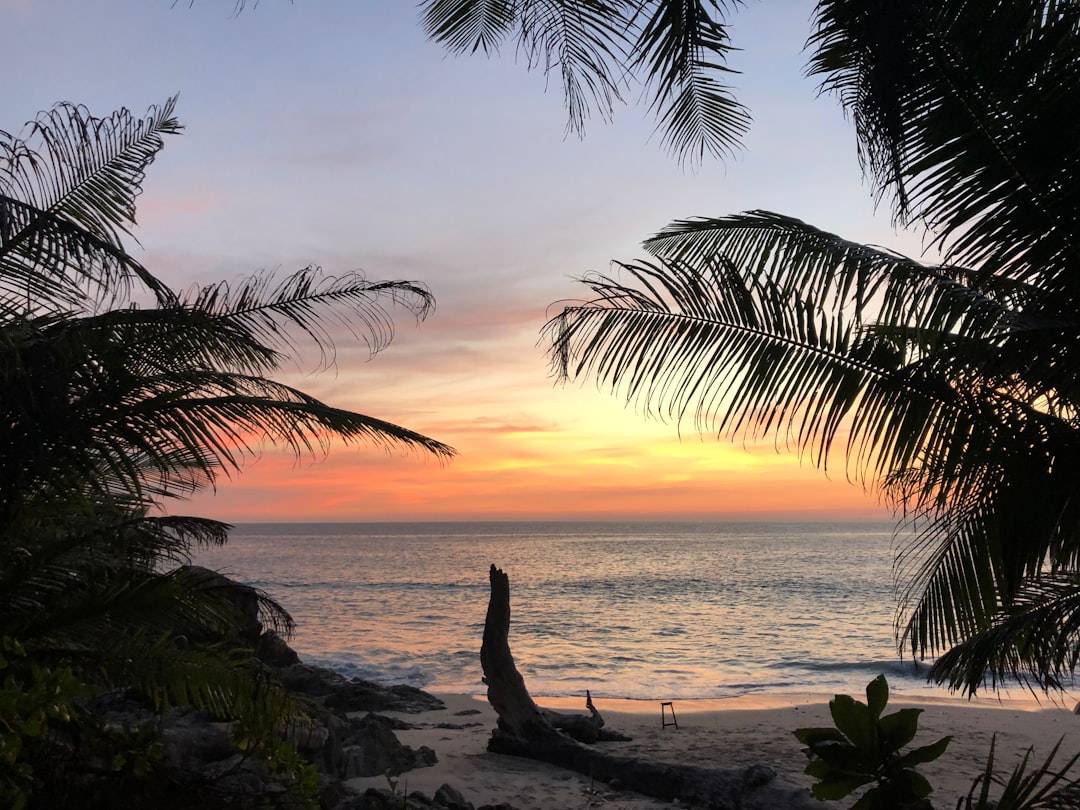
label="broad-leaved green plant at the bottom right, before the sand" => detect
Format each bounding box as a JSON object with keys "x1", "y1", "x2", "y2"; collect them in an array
[{"x1": 795, "y1": 675, "x2": 953, "y2": 810}]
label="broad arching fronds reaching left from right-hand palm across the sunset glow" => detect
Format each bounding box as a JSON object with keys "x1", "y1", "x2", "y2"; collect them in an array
[{"x1": 548, "y1": 214, "x2": 1019, "y2": 482}]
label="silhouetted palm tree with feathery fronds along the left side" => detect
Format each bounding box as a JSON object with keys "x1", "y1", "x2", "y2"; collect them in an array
[{"x1": 0, "y1": 99, "x2": 454, "y2": 800}]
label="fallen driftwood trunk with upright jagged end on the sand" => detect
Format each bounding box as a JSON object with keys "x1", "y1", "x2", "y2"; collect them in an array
[{"x1": 480, "y1": 565, "x2": 820, "y2": 810}]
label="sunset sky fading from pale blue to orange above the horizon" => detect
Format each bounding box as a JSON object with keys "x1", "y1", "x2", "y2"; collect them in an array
[{"x1": 0, "y1": 0, "x2": 920, "y2": 523}]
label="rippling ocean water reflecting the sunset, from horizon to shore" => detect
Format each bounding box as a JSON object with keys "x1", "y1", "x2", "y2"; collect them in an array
[{"x1": 194, "y1": 522, "x2": 963, "y2": 700}]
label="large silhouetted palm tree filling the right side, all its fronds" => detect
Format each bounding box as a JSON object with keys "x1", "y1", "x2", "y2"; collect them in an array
[{"x1": 548, "y1": 0, "x2": 1080, "y2": 693}]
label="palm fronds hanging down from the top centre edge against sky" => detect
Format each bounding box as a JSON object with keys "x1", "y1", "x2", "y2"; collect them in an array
[{"x1": 421, "y1": 0, "x2": 750, "y2": 164}]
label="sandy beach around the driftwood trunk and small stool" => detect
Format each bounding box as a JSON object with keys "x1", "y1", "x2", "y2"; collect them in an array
[{"x1": 349, "y1": 693, "x2": 1080, "y2": 810}]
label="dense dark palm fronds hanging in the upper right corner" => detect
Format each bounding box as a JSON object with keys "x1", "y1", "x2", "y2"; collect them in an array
[{"x1": 810, "y1": 0, "x2": 1080, "y2": 291}]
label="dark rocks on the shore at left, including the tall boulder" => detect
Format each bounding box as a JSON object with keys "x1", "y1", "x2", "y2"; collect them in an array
[{"x1": 79, "y1": 575, "x2": 512, "y2": 810}]
